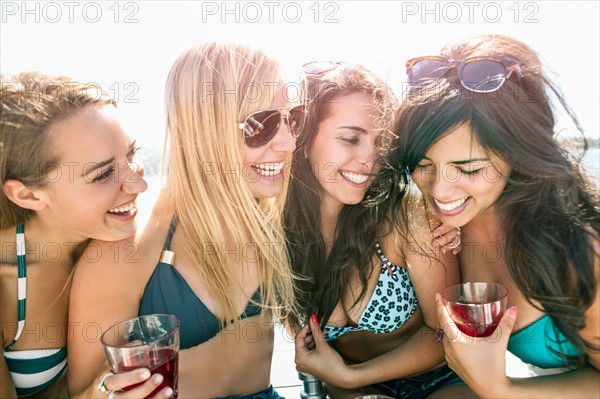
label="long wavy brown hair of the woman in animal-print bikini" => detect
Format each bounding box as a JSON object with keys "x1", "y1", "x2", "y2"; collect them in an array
[{"x1": 284, "y1": 64, "x2": 397, "y2": 330}]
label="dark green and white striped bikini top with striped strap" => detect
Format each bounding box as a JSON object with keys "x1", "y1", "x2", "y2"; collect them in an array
[{"x1": 4, "y1": 224, "x2": 67, "y2": 397}]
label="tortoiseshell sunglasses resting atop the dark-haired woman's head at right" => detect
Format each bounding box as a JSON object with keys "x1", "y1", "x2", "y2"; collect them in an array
[{"x1": 406, "y1": 55, "x2": 521, "y2": 93}]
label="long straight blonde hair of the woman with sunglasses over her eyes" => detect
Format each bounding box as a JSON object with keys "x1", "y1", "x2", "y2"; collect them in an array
[{"x1": 165, "y1": 43, "x2": 294, "y2": 323}]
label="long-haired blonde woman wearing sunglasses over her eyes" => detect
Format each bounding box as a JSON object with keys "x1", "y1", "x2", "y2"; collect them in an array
[{"x1": 69, "y1": 43, "x2": 304, "y2": 399}]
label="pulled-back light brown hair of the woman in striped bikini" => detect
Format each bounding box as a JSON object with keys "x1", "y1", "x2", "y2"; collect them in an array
[{"x1": 0, "y1": 72, "x2": 116, "y2": 228}]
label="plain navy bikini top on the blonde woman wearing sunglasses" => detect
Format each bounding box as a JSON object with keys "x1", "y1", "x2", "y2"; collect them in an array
[{"x1": 138, "y1": 219, "x2": 261, "y2": 349}]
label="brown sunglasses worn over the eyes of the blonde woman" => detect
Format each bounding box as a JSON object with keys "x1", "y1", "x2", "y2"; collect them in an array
[{"x1": 239, "y1": 105, "x2": 304, "y2": 148}]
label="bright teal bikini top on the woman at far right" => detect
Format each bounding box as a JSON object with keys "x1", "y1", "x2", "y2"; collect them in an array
[{"x1": 508, "y1": 315, "x2": 580, "y2": 369}]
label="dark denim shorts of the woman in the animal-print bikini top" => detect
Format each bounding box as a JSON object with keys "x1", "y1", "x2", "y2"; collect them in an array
[{"x1": 371, "y1": 366, "x2": 464, "y2": 399}]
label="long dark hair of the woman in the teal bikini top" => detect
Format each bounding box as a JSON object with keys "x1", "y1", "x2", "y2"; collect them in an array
[{"x1": 389, "y1": 35, "x2": 600, "y2": 364}]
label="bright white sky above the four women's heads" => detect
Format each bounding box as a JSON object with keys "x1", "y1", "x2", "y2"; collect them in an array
[{"x1": 0, "y1": 0, "x2": 600, "y2": 147}]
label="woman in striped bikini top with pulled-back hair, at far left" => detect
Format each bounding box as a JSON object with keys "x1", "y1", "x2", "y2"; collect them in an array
[{"x1": 0, "y1": 72, "x2": 147, "y2": 398}]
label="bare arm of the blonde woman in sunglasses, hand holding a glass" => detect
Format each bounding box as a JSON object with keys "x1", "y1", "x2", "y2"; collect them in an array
[{"x1": 68, "y1": 239, "x2": 168, "y2": 398}]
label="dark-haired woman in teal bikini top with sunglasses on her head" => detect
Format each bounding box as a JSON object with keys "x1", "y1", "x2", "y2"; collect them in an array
[{"x1": 391, "y1": 36, "x2": 600, "y2": 398}]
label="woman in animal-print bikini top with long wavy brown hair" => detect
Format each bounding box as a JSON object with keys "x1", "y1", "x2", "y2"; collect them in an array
[{"x1": 284, "y1": 62, "x2": 460, "y2": 398}]
